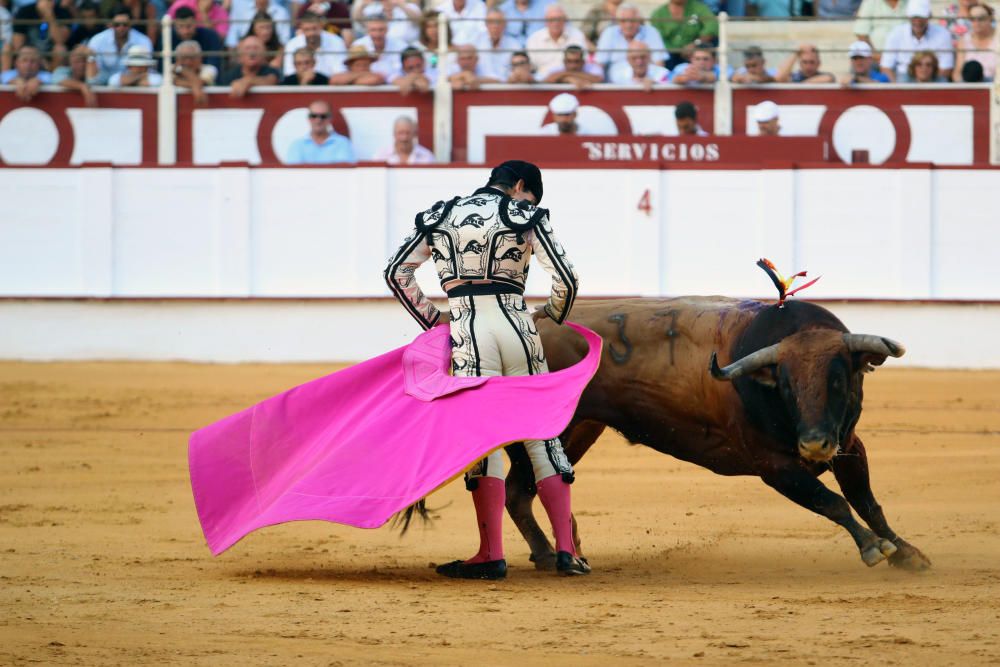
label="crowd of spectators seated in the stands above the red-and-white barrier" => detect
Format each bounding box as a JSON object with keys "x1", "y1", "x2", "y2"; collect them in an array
[{"x1": 0, "y1": 0, "x2": 1000, "y2": 97}]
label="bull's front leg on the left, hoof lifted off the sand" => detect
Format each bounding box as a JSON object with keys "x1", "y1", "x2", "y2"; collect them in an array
[{"x1": 761, "y1": 461, "x2": 896, "y2": 567}]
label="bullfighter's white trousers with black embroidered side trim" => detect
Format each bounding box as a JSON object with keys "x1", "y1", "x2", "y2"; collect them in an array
[{"x1": 448, "y1": 294, "x2": 573, "y2": 489}]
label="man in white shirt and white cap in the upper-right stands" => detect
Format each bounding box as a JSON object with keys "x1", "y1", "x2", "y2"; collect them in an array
[{"x1": 879, "y1": 0, "x2": 955, "y2": 81}]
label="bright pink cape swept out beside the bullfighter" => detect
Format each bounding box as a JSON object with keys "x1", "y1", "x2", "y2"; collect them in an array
[{"x1": 188, "y1": 323, "x2": 601, "y2": 555}]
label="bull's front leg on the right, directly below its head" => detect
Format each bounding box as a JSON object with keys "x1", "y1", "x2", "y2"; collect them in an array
[{"x1": 832, "y1": 438, "x2": 931, "y2": 571}]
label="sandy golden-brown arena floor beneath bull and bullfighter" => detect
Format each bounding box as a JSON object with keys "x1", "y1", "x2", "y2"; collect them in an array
[{"x1": 0, "y1": 363, "x2": 1000, "y2": 667}]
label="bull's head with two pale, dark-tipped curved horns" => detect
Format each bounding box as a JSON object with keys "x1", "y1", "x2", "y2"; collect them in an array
[{"x1": 709, "y1": 329, "x2": 906, "y2": 462}]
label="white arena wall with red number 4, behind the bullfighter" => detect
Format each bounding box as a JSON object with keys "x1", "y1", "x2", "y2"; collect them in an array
[{"x1": 0, "y1": 166, "x2": 1000, "y2": 368}]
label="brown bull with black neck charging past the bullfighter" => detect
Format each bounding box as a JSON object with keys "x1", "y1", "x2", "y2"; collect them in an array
[{"x1": 507, "y1": 297, "x2": 930, "y2": 570}]
